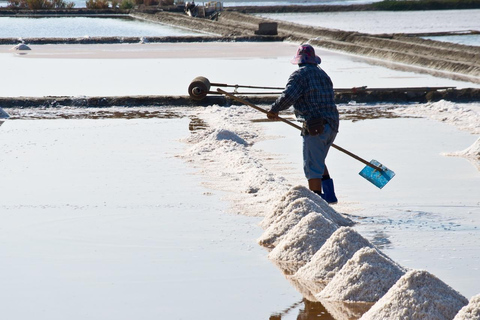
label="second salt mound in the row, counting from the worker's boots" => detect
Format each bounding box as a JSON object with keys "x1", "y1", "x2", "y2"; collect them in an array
[{"x1": 257, "y1": 198, "x2": 322, "y2": 247}]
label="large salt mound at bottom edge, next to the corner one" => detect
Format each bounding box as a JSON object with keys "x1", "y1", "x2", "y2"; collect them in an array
[{"x1": 360, "y1": 270, "x2": 468, "y2": 320}]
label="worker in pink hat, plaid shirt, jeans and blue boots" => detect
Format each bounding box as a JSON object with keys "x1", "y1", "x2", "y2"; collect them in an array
[{"x1": 267, "y1": 44, "x2": 339, "y2": 203}]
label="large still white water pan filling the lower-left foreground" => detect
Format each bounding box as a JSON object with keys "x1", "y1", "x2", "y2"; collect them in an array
[{"x1": 0, "y1": 118, "x2": 301, "y2": 319}]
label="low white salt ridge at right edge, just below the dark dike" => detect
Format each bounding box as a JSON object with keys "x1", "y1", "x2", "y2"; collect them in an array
[{"x1": 394, "y1": 100, "x2": 480, "y2": 134}]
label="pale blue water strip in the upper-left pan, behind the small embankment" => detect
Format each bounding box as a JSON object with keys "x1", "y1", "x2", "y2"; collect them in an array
[{"x1": 0, "y1": 17, "x2": 198, "y2": 38}]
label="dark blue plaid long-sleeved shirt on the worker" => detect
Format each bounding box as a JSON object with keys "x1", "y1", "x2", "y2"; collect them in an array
[{"x1": 270, "y1": 64, "x2": 339, "y2": 131}]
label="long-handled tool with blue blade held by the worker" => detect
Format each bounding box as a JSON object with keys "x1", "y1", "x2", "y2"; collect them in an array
[{"x1": 217, "y1": 88, "x2": 395, "y2": 189}]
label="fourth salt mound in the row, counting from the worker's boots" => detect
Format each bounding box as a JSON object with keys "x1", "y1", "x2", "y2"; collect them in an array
[{"x1": 294, "y1": 227, "x2": 373, "y2": 284}]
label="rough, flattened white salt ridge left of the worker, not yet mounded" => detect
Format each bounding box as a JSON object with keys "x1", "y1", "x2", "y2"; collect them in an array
[{"x1": 182, "y1": 106, "x2": 291, "y2": 216}]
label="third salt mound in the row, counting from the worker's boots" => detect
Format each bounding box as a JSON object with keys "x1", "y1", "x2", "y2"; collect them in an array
[{"x1": 268, "y1": 212, "x2": 338, "y2": 265}]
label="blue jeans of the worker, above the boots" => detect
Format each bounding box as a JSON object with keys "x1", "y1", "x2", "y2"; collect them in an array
[{"x1": 303, "y1": 123, "x2": 337, "y2": 180}]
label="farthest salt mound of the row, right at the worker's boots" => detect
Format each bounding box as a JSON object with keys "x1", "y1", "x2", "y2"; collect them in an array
[{"x1": 260, "y1": 186, "x2": 353, "y2": 229}]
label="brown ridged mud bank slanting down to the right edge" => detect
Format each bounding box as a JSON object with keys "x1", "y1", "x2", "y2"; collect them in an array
[{"x1": 132, "y1": 11, "x2": 480, "y2": 83}]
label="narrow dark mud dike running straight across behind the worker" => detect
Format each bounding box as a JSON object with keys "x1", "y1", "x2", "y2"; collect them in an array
[{"x1": 0, "y1": 88, "x2": 480, "y2": 109}]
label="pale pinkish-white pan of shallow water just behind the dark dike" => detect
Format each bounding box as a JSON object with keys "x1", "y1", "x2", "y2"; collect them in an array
[{"x1": 0, "y1": 43, "x2": 480, "y2": 97}]
